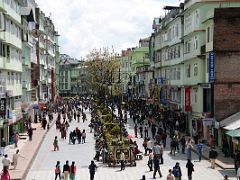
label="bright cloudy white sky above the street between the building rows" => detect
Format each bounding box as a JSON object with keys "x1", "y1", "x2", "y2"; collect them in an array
[{"x1": 35, "y1": 0, "x2": 180, "y2": 59}]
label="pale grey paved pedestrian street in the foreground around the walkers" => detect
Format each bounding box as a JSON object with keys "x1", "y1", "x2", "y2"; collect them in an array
[{"x1": 26, "y1": 111, "x2": 236, "y2": 180}]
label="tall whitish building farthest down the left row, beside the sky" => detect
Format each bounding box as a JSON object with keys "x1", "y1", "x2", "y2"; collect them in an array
[{"x1": 32, "y1": 8, "x2": 58, "y2": 102}]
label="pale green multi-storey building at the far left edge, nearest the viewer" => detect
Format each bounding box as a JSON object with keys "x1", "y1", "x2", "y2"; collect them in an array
[{"x1": 0, "y1": 0, "x2": 22, "y2": 142}]
